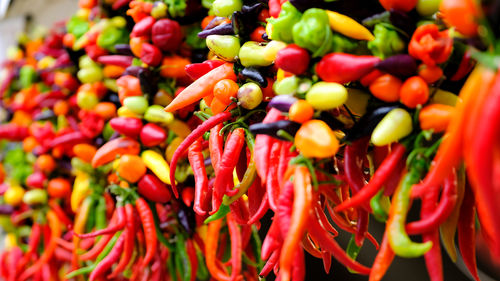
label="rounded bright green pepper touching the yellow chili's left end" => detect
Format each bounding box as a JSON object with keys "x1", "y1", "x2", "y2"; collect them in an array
[{"x1": 292, "y1": 8, "x2": 333, "y2": 57}]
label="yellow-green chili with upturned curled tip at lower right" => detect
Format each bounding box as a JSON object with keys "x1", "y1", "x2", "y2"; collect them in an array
[{"x1": 386, "y1": 165, "x2": 432, "y2": 257}]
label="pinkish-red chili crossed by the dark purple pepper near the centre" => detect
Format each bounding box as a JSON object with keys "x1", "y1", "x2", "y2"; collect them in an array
[{"x1": 254, "y1": 108, "x2": 284, "y2": 184}]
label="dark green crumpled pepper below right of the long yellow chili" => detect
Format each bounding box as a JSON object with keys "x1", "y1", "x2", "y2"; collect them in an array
[{"x1": 367, "y1": 23, "x2": 406, "y2": 59}]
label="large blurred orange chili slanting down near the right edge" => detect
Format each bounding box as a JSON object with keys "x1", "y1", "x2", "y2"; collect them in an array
[{"x1": 412, "y1": 67, "x2": 494, "y2": 197}]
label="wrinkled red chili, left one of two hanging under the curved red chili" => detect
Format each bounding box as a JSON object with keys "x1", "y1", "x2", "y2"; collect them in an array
[{"x1": 188, "y1": 138, "x2": 210, "y2": 216}]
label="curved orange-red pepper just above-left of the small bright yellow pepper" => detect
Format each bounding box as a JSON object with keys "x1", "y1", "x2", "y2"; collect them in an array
[{"x1": 92, "y1": 137, "x2": 140, "y2": 168}]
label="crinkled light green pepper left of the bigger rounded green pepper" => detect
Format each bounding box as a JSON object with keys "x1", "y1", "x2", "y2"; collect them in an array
[{"x1": 267, "y1": 1, "x2": 300, "y2": 43}]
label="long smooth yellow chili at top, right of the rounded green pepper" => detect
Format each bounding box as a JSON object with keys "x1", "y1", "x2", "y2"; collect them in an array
[{"x1": 326, "y1": 11, "x2": 375, "y2": 41}]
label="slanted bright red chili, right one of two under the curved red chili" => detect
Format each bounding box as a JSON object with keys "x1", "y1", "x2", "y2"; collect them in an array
[{"x1": 212, "y1": 128, "x2": 245, "y2": 212}]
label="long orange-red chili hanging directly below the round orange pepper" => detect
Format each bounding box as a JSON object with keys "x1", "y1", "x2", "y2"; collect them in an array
[{"x1": 280, "y1": 166, "x2": 312, "y2": 281}]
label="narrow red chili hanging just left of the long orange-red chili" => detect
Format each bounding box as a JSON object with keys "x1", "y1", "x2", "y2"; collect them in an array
[{"x1": 266, "y1": 141, "x2": 282, "y2": 211}]
